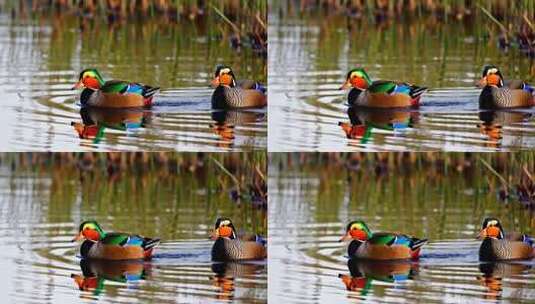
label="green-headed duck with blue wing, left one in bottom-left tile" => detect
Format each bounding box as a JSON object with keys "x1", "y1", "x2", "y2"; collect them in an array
[{"x1": 73, "y1": 221, "x2": 160, "y2": 260}]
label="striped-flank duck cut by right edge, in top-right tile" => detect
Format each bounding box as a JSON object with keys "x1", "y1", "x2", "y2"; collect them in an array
[{"x1": 479, "y1": 65, "x2": 535, "y2": 109}]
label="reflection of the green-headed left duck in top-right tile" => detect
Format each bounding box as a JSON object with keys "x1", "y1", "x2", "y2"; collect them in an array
[{"x1": 338, "y1": 106, "x2": 419, "y2": 144}]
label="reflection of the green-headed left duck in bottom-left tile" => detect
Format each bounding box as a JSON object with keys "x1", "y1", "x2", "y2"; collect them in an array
[{"x1": 71, "y1": 259, "x2": 150, "y2": 295}]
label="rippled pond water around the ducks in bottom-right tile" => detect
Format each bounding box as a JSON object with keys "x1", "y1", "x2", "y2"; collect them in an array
[{"x1": 268, "y1": 157, "x2": 535, "y2": 303}]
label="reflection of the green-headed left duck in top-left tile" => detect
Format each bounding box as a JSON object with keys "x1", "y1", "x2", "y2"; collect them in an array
[{"x1": 71, "y1": 107, "x2": 152, "y2": 143}]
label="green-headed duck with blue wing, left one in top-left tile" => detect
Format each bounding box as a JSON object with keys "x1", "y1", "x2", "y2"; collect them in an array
[{"x1": 73, "y1": 69, "x2": 160, "y2": 108}]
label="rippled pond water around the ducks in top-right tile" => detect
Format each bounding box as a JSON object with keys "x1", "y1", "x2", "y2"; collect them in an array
[{"x1": 269, "y1": 5, "x2": 535, "y2": 151}]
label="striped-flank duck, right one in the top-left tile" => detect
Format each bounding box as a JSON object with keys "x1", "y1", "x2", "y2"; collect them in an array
[{"x1": 212, "y1": 65, "x2": 267, "y2": 109}]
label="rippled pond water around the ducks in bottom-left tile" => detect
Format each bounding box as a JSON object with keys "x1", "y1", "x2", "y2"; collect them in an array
[{"x1": 0, "y1": 158, "x2": 267, "y2": 303}]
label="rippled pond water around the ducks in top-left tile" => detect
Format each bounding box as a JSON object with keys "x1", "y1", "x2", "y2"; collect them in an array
[{"x1": 0, "y1": 13, "x2": 267, "y2": 151}]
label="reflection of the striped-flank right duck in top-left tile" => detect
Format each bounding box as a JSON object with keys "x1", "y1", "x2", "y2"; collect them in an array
[{"x1": 209, "y1": 110, "x2": 266, "y2": 148}]
